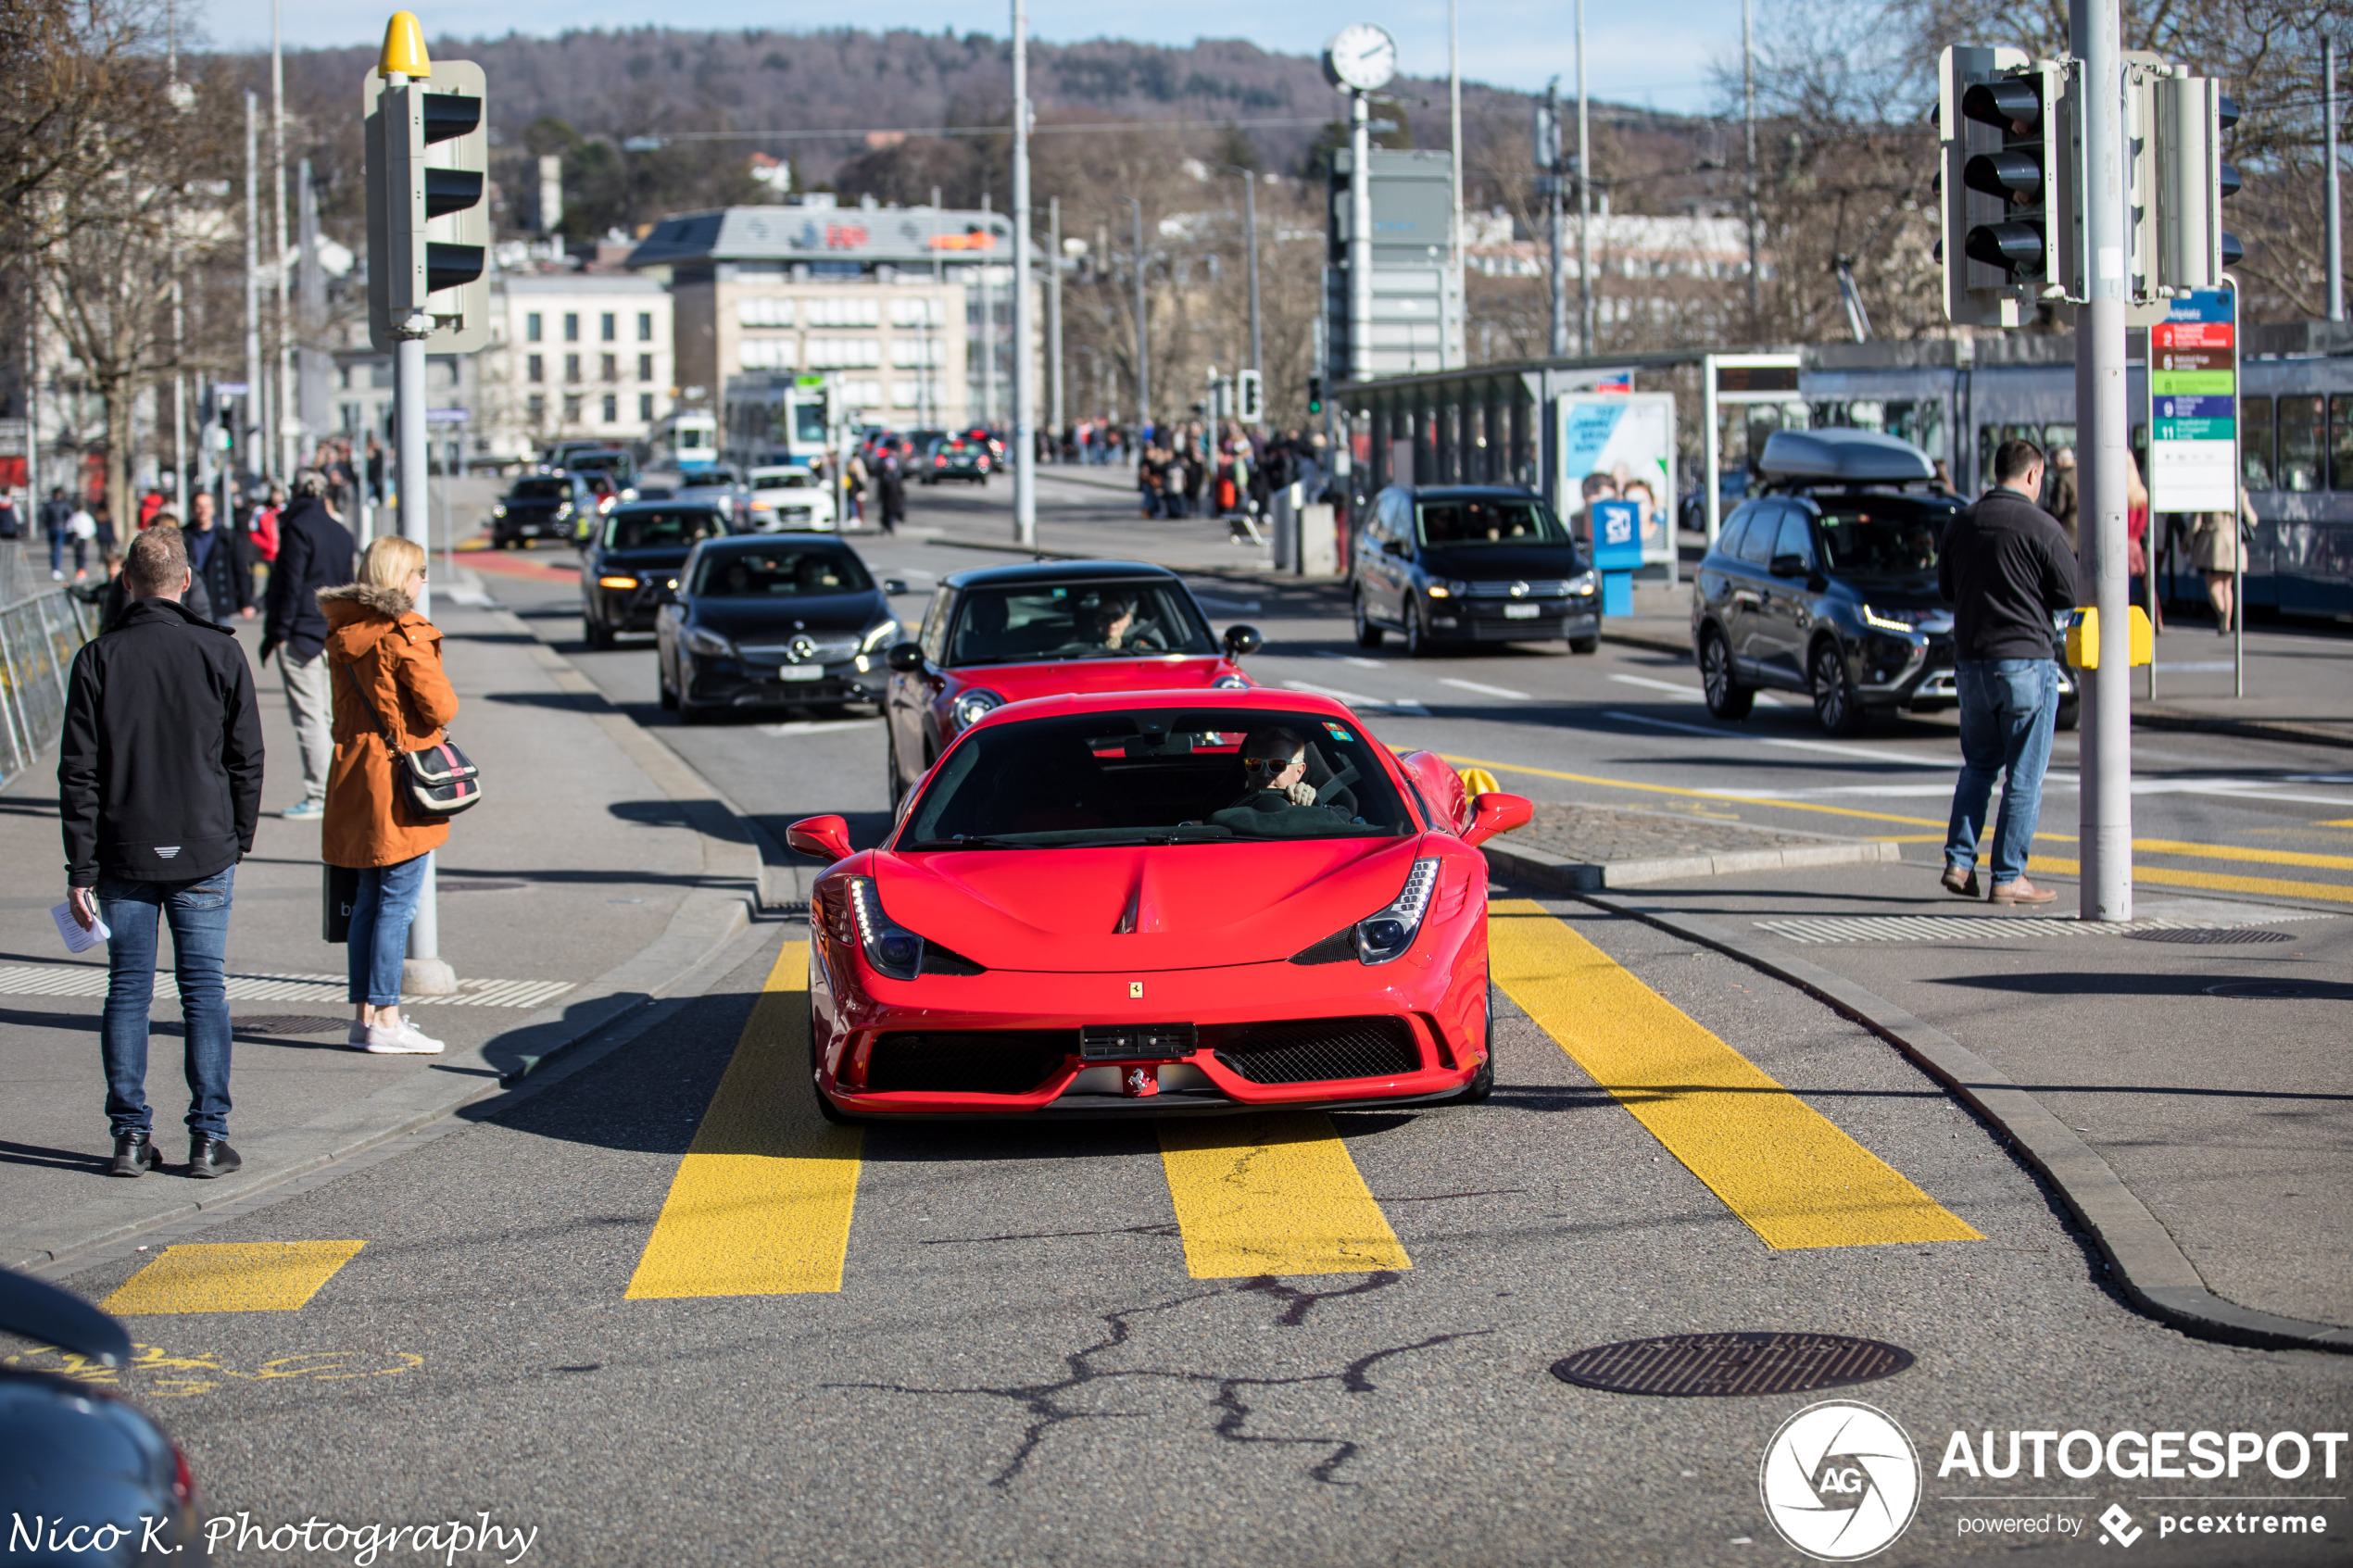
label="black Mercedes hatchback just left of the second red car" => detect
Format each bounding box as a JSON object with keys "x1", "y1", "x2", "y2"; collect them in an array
[{"x1": 654, "y1": 533, "x2": 906, "y2": 724}]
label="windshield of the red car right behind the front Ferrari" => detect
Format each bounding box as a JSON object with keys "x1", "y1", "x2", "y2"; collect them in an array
[{"x1": 949, "y1": 578, "x2": 1216, "y2": 665}]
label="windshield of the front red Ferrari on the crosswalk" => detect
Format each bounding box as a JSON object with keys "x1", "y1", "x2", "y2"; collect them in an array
[{"x1": 897, "y1": 708, "x2": 1415, "y2": 851}]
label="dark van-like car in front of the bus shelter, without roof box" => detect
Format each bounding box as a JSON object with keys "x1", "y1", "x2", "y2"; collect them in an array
[{"x1": 1348, "y1": 484, "x2": 1603, "y2": 656}]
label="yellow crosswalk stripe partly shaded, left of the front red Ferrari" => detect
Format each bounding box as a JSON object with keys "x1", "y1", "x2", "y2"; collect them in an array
[{"x1": 628, "y1": 943, "x2": 863, "y2": 1300}]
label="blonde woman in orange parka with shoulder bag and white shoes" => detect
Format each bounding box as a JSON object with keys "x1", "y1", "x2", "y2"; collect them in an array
[{"x1": 318, "y1": 536, "x2": 457, "y2": 1056}]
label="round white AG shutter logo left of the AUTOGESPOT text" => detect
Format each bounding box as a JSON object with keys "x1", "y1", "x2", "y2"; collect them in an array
[{"x1": 1757, "y1": 1399, "x2": 1920, "y2": 1563}]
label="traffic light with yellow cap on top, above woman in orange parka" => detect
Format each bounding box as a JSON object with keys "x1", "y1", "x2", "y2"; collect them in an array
[{"x1": 362, "y1": 12, "x2": 489, "y2": 355}]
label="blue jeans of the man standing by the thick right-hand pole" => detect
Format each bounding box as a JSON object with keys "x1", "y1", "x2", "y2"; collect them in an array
[{"x1": 1944, "y1": 659, "x2": 2059, "y2": 886}]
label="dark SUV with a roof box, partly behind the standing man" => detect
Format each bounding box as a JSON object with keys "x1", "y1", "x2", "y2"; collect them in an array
[{"x1": 1692, "y1": 430, "x2": 2075, "y2": 735}]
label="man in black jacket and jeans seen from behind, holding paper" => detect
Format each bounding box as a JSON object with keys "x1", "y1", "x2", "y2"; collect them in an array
[{"x1": 57, "y1": 529, "x2": 261, "y2": 1178}]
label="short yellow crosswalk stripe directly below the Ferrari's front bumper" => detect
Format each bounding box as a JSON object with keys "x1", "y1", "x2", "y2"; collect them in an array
[{"x1": 1160, "y1": 1112, "x2": 1415, "y2": 1279}]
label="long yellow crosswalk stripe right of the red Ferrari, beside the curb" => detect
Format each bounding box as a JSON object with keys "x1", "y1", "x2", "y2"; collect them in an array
[{"x1": 1490, "y1": 898, "x2": 1983, "y2": 1248}]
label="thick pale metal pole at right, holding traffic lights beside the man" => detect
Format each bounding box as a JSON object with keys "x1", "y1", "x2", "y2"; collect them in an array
[{"x1": 2069, "y1": 0, "x2": 2132, "y2": 919}]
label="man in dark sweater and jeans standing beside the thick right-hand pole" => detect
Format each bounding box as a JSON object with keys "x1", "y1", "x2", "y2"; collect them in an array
[{"x1": 1936, "y1": 440, "x2": 2075, "y2": 905}]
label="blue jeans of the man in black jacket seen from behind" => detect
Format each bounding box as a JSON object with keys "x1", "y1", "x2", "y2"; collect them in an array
[{"x1": 96, "y1": 865, "x2": 238, "y2": 1138}]
